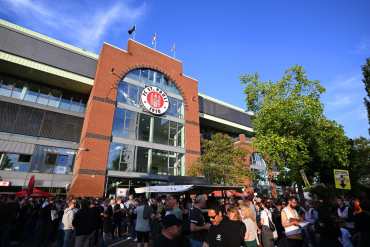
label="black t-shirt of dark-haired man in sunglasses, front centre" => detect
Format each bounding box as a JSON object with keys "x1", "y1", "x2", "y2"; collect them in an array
[{"x1": 208, "y1": 217, "x2": 241, "y2": 247}]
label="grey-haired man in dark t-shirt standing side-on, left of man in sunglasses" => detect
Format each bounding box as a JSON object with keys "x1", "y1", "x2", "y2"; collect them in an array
[{"x1": 190, "y1": 195, "x2": 210, "y2": 247}]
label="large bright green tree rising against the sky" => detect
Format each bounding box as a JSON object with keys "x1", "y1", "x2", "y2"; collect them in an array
[{"x1": 239, "y1": 65, "x2": 349, "y2": 204}]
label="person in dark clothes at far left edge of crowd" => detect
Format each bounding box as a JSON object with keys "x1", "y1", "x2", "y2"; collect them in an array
[{"x1": 0, "y1": 195, "x2": 19, "y2": 247}]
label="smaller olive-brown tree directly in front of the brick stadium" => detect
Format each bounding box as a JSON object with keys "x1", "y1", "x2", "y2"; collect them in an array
[{"x1": 188, "y1": 133, "x2": 255, "y2": 186}]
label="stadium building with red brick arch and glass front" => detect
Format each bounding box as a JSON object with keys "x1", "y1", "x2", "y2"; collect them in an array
[{"x1": 0, "y1": 20, "x2": 278, "y2": 197}]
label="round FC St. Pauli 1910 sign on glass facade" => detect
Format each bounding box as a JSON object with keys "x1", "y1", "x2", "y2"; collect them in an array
[{"x1": 140, "y1": 86, "x2": 170, "y2": 115}]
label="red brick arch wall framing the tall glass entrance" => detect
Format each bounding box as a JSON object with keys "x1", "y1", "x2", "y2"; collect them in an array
[{"x1": 69, "y1": 40, "x2": 200, "y2": 197}]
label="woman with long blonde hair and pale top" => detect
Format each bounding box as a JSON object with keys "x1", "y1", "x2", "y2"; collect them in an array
[{"x1": 241, "y1": 204, "x2": 257, "y2": 247}]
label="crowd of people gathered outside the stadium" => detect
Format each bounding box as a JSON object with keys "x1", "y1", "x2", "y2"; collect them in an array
[{"x1": 0, "y1": 194, "x2": 370, "y2": 247}]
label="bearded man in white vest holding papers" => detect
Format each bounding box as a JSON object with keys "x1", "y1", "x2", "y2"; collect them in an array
[{"x1": 281, "y1": 196, "x2": 303, "y2": 247}]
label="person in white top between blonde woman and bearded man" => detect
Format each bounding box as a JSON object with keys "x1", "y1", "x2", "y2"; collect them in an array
[{"x1": 261, "y1": 199, "x2": 274, "y2": 247}]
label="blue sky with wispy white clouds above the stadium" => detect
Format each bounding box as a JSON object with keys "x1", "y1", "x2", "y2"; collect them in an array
[{"x1": 0, "y1": 0, "x2": 370, "y2": 138}]
